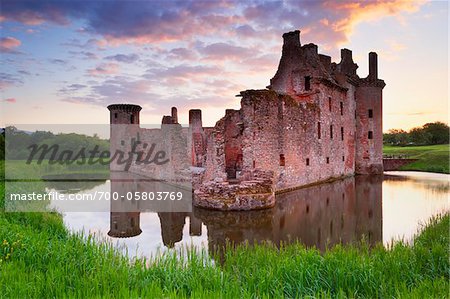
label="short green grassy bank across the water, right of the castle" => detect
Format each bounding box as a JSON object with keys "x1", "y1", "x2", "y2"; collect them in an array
[{"x1": 383, "y1": 144, "x2": 450, "y2": 173}]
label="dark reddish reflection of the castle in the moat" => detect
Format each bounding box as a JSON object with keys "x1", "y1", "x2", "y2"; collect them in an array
[{"x1": 108, "y1": 176, "x2": 383, "y2": 251}]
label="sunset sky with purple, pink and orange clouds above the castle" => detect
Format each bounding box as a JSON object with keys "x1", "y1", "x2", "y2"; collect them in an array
[{"x1": 0, "y1": 0, "x2": 449, "y2": 131}]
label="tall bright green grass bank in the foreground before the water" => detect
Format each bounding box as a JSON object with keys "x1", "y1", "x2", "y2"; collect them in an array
[{"x1": 0, "y1": 177, "x2": 450, "y2": 298}]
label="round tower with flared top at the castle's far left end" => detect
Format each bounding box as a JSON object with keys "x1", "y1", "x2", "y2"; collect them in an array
[{"x1": 108, "y1": 104, "x2": 142, "y2": 171}]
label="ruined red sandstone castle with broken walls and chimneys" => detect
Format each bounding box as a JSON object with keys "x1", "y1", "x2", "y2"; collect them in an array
[{"x1": 108, "y1": 30, "x2": 385, "y2": 210}]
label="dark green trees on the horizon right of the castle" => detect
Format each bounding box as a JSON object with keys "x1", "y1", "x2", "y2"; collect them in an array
[{"x1": 383, "y1": 121, "x2": 449, "y2": 146}]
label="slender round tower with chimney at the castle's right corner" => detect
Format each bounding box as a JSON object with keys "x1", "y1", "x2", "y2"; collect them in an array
[{"x1": 355, "y1": 52, "x2": 386, "y2": 174}]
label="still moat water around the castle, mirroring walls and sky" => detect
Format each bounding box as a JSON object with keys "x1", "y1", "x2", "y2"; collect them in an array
[{"x1": 49, "y1": 172, "x2": 450, "y2": 257}]
